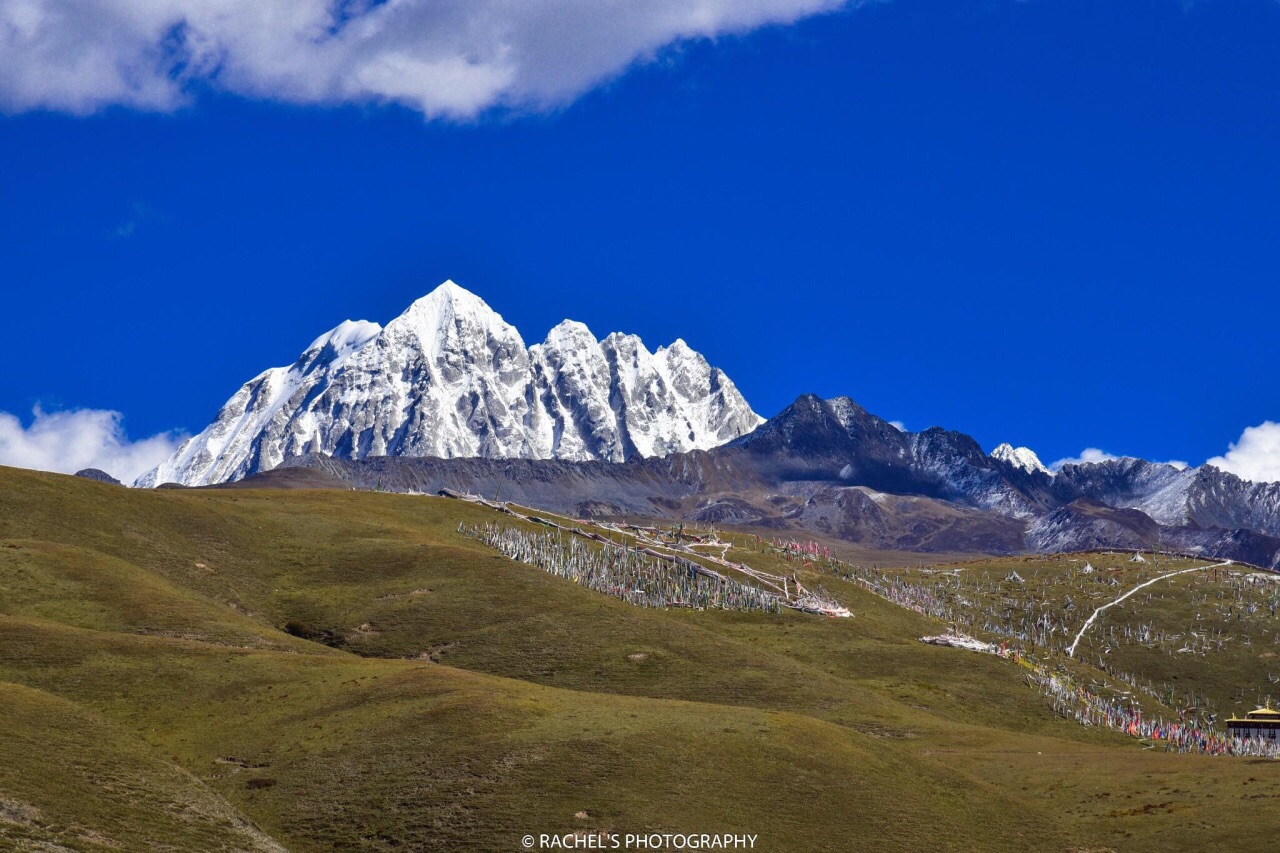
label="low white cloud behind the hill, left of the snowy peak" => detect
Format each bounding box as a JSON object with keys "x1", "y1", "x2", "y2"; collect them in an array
[{"x1": 0, "y1": 406, "x2": 183, "y2": 484}]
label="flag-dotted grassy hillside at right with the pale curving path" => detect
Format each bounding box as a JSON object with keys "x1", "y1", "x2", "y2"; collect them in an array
[{"x1": 885, "y1": 553, "x2": 1280, "y2": 719}]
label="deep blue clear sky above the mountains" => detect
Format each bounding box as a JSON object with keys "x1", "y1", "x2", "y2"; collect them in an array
[{"x1": 0, "y1": 0, "x2": 1280, "y2": 481}]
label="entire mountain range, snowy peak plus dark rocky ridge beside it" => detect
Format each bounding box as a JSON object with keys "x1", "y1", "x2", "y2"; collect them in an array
[{"x1": 137, "y1": 282, "x2": 1280, "y2": 567}]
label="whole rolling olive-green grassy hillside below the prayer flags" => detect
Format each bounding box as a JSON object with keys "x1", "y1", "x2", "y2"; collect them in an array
[{"x1": 0, "y1": 469, "x2": 1280, "y2": 850}]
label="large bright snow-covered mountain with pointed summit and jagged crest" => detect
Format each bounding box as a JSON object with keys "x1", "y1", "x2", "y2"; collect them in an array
[{"x1": 137, "y1": 282, "x2": 762, "y2": 487}]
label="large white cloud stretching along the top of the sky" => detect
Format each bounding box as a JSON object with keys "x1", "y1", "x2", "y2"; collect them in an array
[{"x1": 0, "y1": 0, "x2": 861, "y2": 118}]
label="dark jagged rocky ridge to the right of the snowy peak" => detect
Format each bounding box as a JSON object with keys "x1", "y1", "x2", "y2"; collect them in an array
[{"x1": 264, "y1": 394, "x2": 1280, "y2": 566}]
